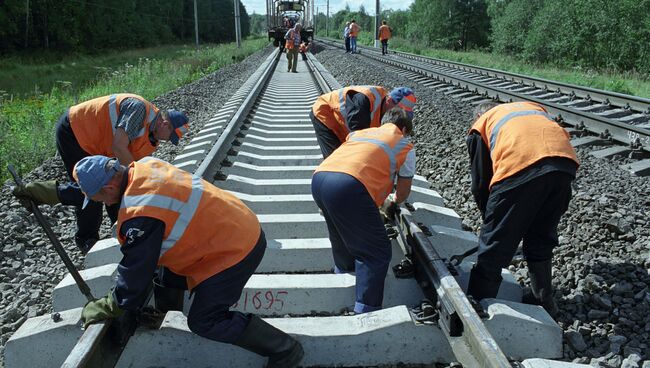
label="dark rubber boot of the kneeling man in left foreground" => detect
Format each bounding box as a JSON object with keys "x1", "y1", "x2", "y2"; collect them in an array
[{"x1": 235, "y1": 315, "x2": 304, "y2": 368}]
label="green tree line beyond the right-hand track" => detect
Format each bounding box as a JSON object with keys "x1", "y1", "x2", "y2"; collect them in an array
[{"x1": 308, "y1": 0, "x2": 650, "y2": 74}]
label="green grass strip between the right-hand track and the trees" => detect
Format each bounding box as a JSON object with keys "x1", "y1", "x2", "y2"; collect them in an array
[{"x1": 342, "y1": 33, "x2": 650, "y2": 98}]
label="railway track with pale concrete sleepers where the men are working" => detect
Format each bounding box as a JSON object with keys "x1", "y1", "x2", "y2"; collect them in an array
[{"x1": 5, "y1": 47, "x2": 562, "y2": 368}]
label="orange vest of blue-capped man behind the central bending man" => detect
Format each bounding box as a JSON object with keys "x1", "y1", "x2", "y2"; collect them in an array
[{"x1": 312, "y1": 86, "x2": 388, "y2": 142}]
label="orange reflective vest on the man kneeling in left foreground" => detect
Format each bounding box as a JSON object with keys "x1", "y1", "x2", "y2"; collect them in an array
[{"x1": 117, "y1": 157, "x2": 261, "y2": 289}]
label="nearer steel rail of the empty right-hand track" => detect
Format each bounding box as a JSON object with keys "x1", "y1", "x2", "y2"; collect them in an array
[{"x1": 321, "y1": 37, "x2": 650, "y2": 152}]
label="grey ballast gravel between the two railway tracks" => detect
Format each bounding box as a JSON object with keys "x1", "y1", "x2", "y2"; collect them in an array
[{"x1": 312, "y1": 46, "x2": 650, "y2": 367}]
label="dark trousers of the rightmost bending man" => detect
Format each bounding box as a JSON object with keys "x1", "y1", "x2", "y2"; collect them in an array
[{"x1": 470, "y1": 171, "x2": 573, "y2": 300}]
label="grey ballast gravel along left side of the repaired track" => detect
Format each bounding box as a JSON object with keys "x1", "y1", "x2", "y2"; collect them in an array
[{"x1": 0, "y1": 47, "x2": 274, "y2": 367}]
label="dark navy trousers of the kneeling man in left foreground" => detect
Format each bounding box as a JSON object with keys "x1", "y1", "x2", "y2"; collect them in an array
[{"x1": 187, "y1": 232, "x2": 266, "y2": 344}]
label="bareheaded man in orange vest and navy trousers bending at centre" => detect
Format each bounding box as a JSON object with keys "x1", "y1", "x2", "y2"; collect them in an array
[{"x1": 311, "y1": 108, "x2": 415, "y2": 313}]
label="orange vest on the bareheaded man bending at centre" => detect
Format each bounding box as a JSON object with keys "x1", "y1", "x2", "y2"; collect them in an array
[{"x1": 315, "y1": 124, "x2": 413, "y2": 207}]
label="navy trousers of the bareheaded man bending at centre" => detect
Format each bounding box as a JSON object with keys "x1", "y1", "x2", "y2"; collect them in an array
[{"x1": 311, "y1": 172, "x2": 391, "y2": 313}]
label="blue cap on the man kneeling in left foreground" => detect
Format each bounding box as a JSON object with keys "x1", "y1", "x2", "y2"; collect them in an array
[{"x1": 72, "y1": 155, "x2": 119, "y2": 208}]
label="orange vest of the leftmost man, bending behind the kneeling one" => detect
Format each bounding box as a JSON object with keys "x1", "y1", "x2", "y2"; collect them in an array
[{"x1": 68, "y1": 93, "x2": 158, "y2": 160}]
